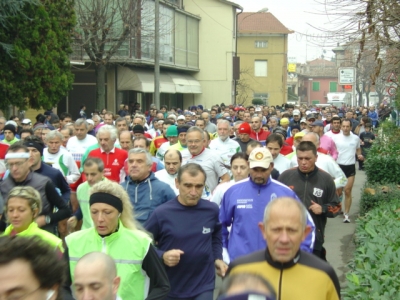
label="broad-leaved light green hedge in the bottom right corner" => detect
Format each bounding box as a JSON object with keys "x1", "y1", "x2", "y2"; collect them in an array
[{"x1": 342, "y1": 198, "x2": 400, "y2": 300}]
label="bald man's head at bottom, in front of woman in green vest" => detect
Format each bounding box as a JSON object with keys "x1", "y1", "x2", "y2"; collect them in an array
[{"x1": 73, "y1": 252, "x2": 122, "y2": 300}]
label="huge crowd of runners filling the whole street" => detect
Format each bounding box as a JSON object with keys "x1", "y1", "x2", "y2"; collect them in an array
[{"x1": 0, "y1": 103, "x2": 395, "y2": 300}]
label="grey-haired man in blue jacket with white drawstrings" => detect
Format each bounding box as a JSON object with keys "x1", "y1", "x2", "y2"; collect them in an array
[{"x1": 121, "y1": 148, "x2": 175, "y2": 224}]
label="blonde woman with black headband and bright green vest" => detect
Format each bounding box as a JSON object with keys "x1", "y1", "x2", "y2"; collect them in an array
[{"x1": 64, "y1": 181, "x2": 169, "y2": 299}]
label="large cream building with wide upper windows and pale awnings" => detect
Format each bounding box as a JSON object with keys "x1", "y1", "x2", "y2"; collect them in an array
[{"x1": 58, "y1": 0, "x2": 242, "y2": 117}]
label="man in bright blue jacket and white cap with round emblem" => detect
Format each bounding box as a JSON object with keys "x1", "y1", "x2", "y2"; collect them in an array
[{"x1": 219, "y1": 148, "x2": 315, "y2": 262}]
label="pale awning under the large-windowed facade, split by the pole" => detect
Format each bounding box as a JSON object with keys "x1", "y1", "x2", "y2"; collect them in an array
[{"x1": 118, "y1": 67, "x2": 201, "y2": 94}]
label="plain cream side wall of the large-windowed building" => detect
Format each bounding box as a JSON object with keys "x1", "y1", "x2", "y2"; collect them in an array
[{"x1": 184, "y1": 0, "x2": 236, "y2": 108}]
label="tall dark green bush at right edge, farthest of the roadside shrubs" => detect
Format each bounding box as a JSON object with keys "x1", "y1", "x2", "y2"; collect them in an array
[{"x1": 364, "y1": 121, "x2": 400, "y2": 183}]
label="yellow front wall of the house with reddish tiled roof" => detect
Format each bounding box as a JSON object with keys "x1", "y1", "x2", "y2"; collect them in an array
[{"x1": 238, "y1": 34, "x2": 287, "y2": 105}]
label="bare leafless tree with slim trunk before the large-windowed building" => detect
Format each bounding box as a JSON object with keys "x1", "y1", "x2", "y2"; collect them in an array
[{"x1": 75, "y1": 0, "x2": 143, "y2": 109}]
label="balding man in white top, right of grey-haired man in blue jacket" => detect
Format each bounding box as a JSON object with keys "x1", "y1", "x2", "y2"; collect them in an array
[{"x1": 154, "y1": 149, "x2": 182, "y2": 196}]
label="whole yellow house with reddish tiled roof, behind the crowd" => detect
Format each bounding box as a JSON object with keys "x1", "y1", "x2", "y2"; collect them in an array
[{"x1": 236, "y1": 12, "x2": 293, "y2": 105}]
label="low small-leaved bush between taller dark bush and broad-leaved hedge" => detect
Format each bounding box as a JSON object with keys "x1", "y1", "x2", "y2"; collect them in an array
[{"x1": 360, "y1": 182, "x2": 400, "y2": 216}]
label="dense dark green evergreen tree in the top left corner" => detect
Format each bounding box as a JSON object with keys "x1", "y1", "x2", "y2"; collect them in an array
[{"x1": 0, "y1": 0, "x2": 75, "y2": 109}]
